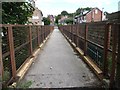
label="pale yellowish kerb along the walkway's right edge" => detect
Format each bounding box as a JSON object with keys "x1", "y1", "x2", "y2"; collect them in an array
[{"x1": 61, "y1": 32, "x2": 103, "y2": 81}]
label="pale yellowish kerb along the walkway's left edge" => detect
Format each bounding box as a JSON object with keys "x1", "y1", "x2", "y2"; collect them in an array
[{"x1": 8, "y1": 32, "x2": 52, "y2": 88}]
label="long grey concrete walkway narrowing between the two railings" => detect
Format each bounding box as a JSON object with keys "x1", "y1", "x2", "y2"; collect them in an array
[{"x1": 22, "y1": 29, "x2": 100, "y2": 88}]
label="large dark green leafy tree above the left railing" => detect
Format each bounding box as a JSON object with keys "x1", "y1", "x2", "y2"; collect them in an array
[{"x1": 2, "y1": 2, "x2": 34, "y2": 24}]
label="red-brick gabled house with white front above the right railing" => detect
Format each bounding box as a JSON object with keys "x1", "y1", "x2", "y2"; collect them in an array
[{"x1": 75, "y1": 8, "x2": 103, "y2": 23}]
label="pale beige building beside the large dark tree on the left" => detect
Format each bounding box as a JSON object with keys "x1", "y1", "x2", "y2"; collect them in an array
[{"x1": 29, "y1": 8, "x2": 43, "y2": 25}]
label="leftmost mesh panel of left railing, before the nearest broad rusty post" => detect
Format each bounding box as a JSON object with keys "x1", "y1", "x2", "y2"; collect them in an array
[{"x1": 2, "y1": 26, "x2": 12, "y2": 82}]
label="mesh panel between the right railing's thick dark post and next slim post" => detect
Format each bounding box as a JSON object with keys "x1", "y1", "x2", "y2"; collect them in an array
[{"x1": 87, "y1": 23, "x2": 106, "y2": 69}]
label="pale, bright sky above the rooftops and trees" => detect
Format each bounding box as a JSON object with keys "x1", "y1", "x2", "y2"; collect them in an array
[{"x1": 35, "y1": 0, "x2": 120, "y2": 17}]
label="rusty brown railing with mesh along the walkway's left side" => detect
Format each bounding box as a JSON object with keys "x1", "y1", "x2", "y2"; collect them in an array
[{"x1": 0, "y1": 24, "x2": 53, "y2": 83}]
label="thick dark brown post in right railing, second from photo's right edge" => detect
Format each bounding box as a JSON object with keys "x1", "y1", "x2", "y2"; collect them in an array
[{"x1": 103, "y1": 24, "x2": 111, "y2": 77}]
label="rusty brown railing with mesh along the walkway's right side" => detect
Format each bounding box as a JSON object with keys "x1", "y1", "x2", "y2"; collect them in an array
[{"x1": 59, "y1": 22, "x2": 120, "y2": 85}]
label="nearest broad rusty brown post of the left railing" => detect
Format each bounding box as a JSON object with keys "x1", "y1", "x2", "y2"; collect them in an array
[{"x1": 8, "y1": 25, "x2": 16, "y2": 78}]
